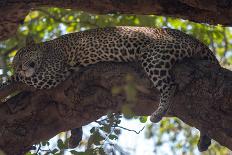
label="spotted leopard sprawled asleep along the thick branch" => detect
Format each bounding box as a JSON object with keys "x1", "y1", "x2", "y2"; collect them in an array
[{"x1": 0, "y1": 26, "x2": 219, "y2": 151}]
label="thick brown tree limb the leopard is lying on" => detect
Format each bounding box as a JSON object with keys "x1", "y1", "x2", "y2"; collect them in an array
[{"x1": 0, "y1": 61, "x2": 232, "y2": 154}]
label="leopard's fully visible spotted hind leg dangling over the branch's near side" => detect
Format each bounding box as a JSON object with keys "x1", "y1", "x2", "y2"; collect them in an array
[{"x1": 138, "y1": 48, "x2": 176, "y2": 123}]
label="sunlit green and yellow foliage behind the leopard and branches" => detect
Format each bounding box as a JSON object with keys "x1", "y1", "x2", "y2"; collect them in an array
[{"x1": 0, "y1": 8, "x2": 232, "y2": 155}]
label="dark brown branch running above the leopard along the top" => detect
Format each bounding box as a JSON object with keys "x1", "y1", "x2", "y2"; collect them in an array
[{"x1": 0, "y1": 0, "x2": 232, "y2": 40}]
